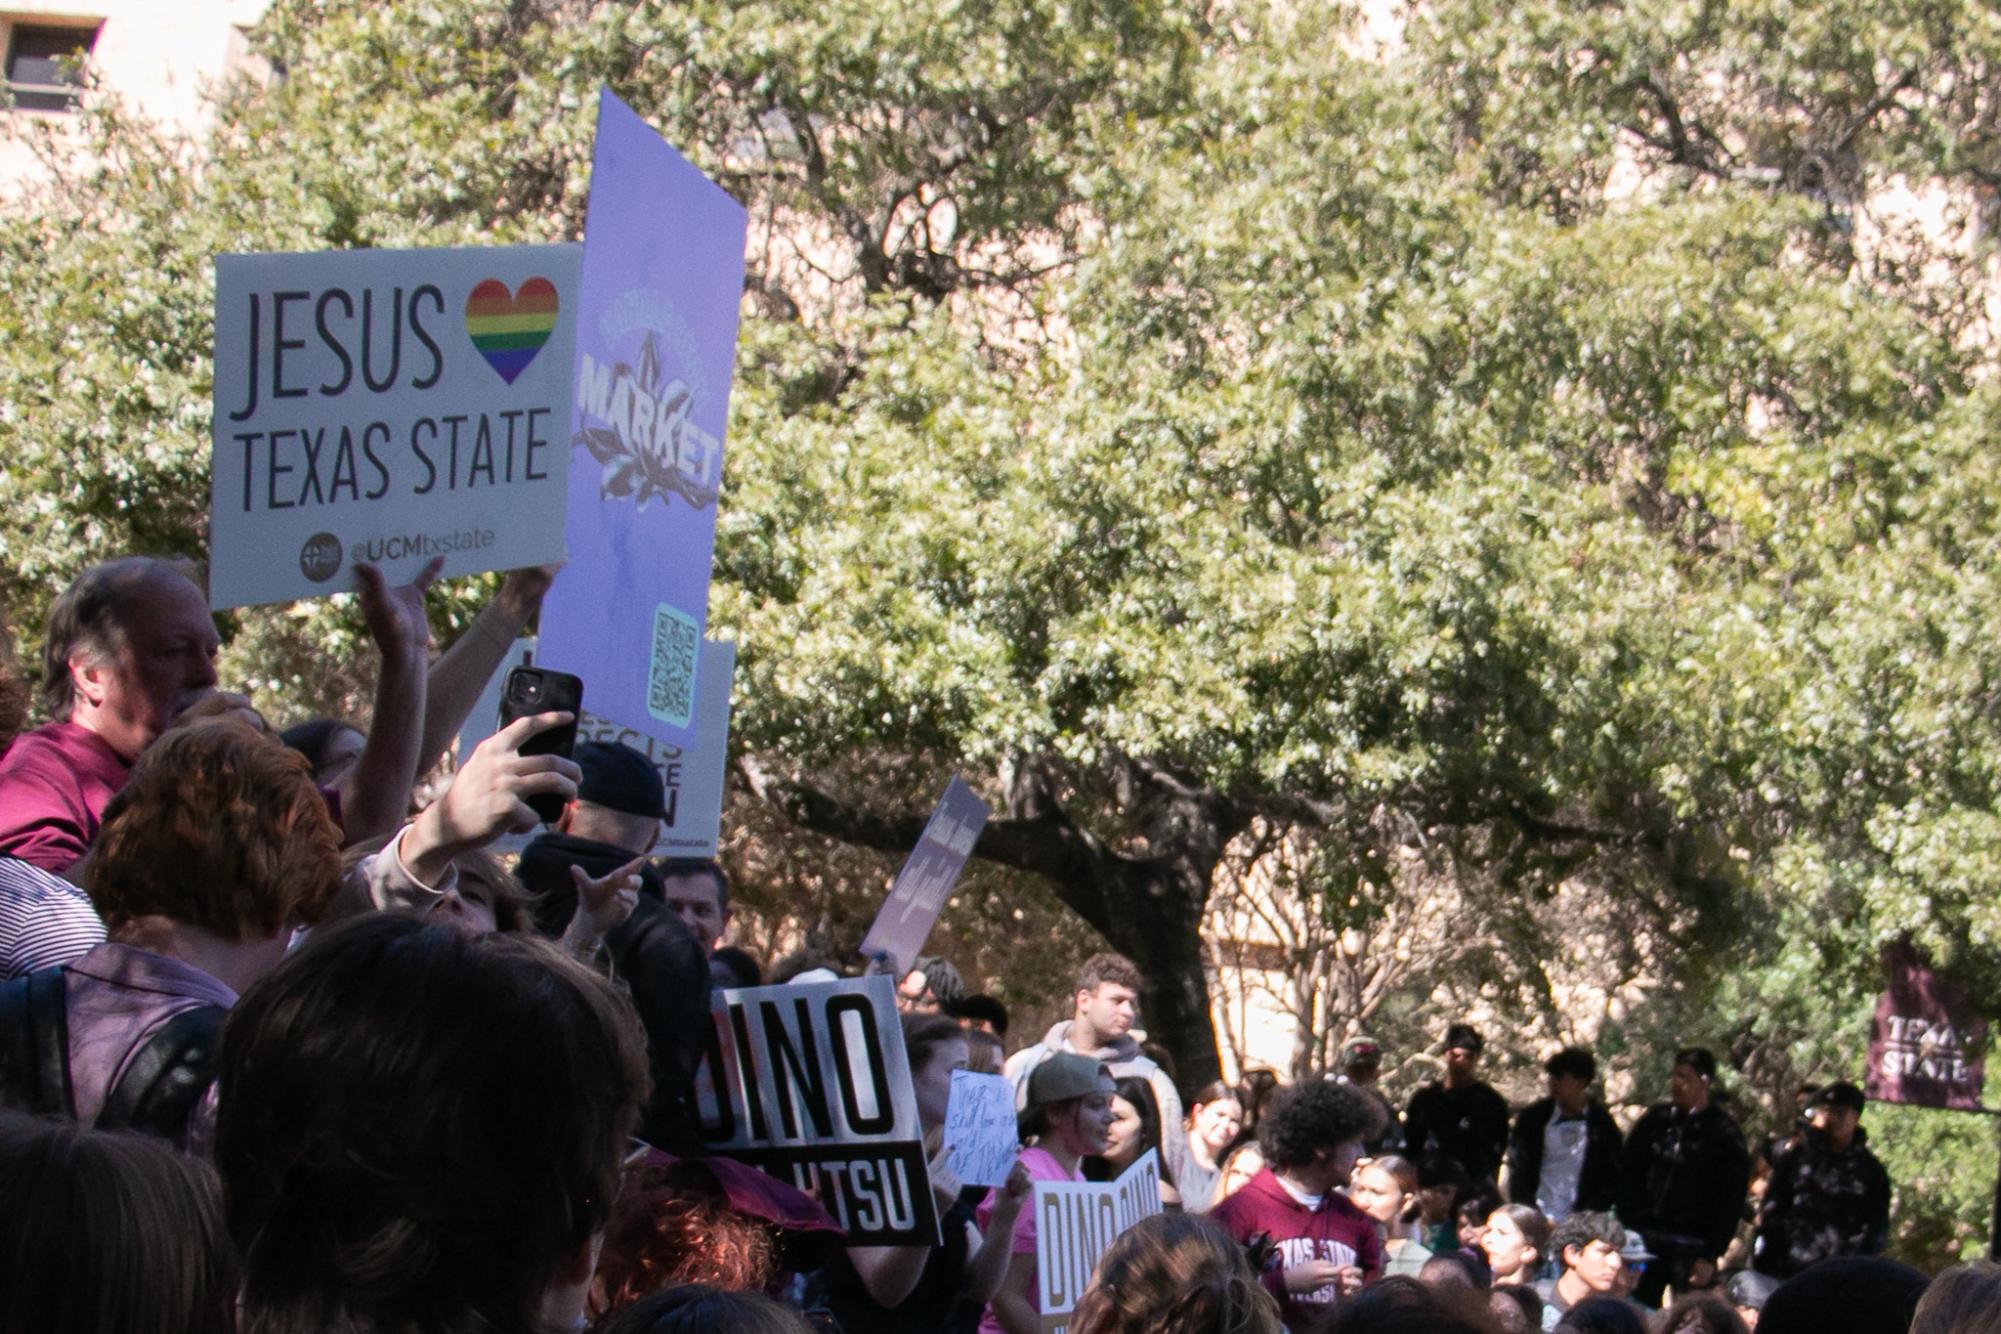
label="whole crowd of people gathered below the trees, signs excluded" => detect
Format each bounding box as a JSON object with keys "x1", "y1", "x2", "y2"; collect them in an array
[{"x1": 0, "y1": 558, "x2": 2001, "y2": 1334}]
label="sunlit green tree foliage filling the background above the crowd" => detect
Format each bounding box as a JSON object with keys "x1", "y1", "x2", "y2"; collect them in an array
[{"x1": 11, "y1": 0, "x2": 2001, "y2": 1240}]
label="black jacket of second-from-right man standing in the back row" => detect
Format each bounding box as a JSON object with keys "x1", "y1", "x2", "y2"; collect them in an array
[{"x1": 1619, "y1": 1102, "x2": 1751, "y2": 1258}]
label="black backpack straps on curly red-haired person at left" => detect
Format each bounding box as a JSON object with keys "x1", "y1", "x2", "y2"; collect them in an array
[{"x1": 0, "y1": 968, "x2": 228, "y2": 1144}]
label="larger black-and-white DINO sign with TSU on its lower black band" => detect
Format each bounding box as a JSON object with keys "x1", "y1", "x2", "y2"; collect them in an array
[{"x1": 694, "y1": 976, "x2": 938, "y2": 1246}]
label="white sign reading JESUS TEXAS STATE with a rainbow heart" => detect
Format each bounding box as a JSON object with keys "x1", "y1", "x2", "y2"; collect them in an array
[{"x1": 208, "y1": 246, "x2": 582, "y2": 610}]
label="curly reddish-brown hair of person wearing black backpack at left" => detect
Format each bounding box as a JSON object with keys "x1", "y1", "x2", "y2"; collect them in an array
[{"x1": 84, "y1": 718, "x2": 340, "y2": 940}]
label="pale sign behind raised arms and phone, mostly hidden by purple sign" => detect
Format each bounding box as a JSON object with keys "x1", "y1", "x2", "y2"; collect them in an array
[{"x1": 458, "y1": 636, "x2": 736, "y2": 858}]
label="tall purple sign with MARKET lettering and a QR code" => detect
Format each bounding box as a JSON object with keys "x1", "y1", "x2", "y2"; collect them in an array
[{"x1": 540, "y1": 88, "x2": 746, "y2": 748}]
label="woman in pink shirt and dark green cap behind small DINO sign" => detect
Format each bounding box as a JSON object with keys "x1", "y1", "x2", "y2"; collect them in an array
[{"x1": 978, "y1": 1052, "x2": 1113, "y2": 1334}]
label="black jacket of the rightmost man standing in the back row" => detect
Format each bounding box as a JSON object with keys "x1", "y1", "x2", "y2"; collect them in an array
[{"x1": 1753, "y1": 1130, "x2": 1889, "y2": 1278}]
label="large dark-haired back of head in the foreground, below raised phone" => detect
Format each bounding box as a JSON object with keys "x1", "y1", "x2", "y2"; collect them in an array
[{"x1": 216, "y1": 914, "x2": 648, "y2": 1334}]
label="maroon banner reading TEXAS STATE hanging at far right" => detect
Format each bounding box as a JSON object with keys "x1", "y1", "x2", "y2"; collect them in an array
[{"x1": 1863, "y1": 944, "x2": 1987, "y2": 1112}]
